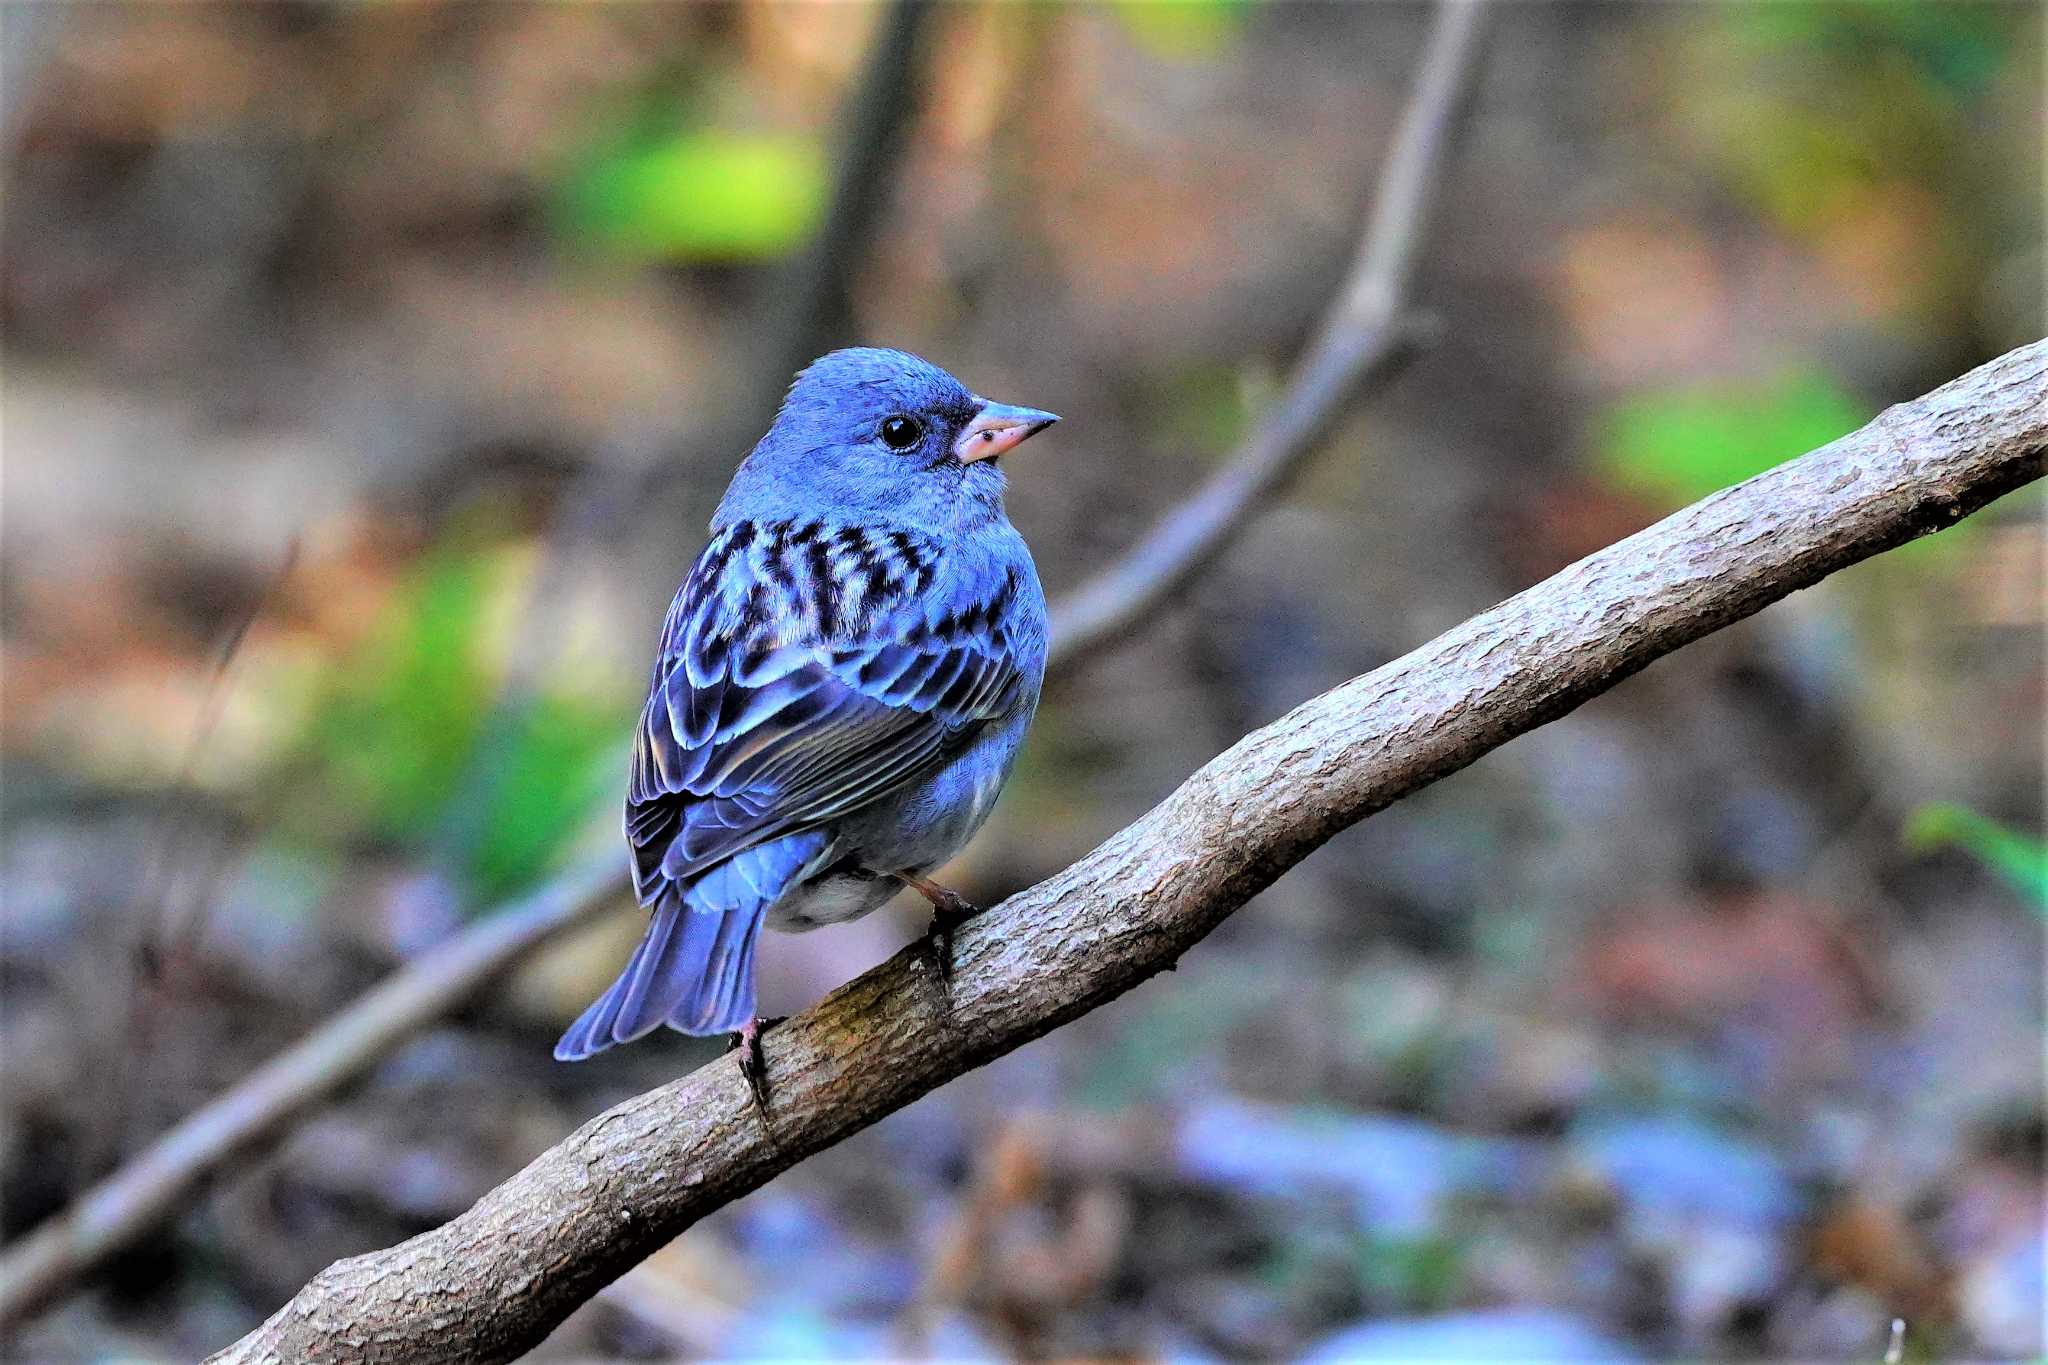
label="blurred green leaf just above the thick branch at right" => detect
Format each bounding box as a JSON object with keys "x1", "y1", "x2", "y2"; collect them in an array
[{"x1": 1595, "y1": 370, "x2": 1870, "y2": 508}]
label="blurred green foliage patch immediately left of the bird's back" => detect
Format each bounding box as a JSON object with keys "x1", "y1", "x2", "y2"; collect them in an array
[{"x1": 284, "y1": 536, "x2": 629, "y2": 902}]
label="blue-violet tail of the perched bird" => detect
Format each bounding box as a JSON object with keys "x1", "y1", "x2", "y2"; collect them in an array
[{"x1": 555, "y1": 831, "x2": 825, "y2": 1062}]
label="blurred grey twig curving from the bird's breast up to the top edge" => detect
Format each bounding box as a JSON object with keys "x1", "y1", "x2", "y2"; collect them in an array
[{"x1": 1053, "y1": 0, "x2": 1485, "y2": 665}]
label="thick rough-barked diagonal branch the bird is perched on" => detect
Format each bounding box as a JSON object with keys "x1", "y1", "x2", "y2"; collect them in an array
[{"x1": 213, "y1": 342, "x2": 2048, "y2": 1361}]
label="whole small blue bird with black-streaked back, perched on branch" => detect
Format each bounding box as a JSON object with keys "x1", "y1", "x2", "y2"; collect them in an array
[{"x1": 555, "y1": 348, "x2": 1059, "y2": 1095}]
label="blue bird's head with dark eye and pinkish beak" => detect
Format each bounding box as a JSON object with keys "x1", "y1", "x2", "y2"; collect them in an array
[{"x1": 721, "y1": 346, "x2": 1059, "y2": 518}]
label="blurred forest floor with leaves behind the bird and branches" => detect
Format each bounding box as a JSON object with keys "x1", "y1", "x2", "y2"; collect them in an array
[{"x1": 0, "y1": 0, "x2": 2048, "y2": 1361}]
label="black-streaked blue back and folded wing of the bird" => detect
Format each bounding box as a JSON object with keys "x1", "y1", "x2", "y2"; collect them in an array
[{"x1": 627, "y1": 522, "x2": 1028, "y2": 898}]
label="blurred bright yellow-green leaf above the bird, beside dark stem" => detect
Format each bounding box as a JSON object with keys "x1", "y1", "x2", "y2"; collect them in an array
[{"x1": 555, "y1": 129, "x2": 825, "y2": 262}]
